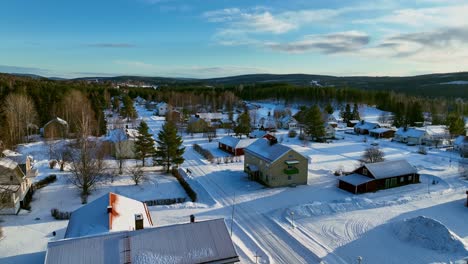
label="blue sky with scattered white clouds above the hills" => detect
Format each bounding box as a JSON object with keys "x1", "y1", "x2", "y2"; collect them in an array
[{"x1": 0, "y1": 0, "x2": 468, "y2": 78}]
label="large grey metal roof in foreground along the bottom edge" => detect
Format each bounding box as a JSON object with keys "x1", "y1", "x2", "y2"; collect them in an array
[{"x1": 45, "y1": 219, "x2": 239, "y2": 264}]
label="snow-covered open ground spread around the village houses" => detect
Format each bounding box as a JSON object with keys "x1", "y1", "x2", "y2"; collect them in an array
[{"x1": 0, "y1": 104, "x2": 468, "y2": 263}]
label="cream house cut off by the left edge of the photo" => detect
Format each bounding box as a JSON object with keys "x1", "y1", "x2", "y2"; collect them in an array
[{"x1": 0, "y1": 158, "x2": 33, "y2": 214}]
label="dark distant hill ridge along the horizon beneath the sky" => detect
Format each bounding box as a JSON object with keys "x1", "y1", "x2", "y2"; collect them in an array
[{"x1": 3, "y1": 72, "x2": 468, "y2": 98}]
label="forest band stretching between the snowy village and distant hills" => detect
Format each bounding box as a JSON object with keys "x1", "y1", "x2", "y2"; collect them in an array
[{"x1": 0, "y1": 74, "x2": 468, "y2": 150}]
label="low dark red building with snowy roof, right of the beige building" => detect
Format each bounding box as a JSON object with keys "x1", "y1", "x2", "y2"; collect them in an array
[{"x1": 338, "y1": 160, "x2": 419, "y2": 194}]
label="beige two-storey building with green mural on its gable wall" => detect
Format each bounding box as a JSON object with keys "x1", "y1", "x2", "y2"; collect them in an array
[{"x1": 244, "y1": 138, "x2": 308, "y2": 187}]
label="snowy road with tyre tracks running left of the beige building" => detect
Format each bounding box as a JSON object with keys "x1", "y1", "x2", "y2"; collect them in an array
[{"x1": 184, "y1": 148, "x2": 321, "y2": 263}]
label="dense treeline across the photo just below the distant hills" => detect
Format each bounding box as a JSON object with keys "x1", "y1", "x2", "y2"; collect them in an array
[{"x1": 0, "y1": 74, "x2": 468, "y2": 148}]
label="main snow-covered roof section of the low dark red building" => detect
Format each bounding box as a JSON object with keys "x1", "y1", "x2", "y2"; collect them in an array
[{"x1": 364, "y1": 160, "x2": 418, "y2": 179}]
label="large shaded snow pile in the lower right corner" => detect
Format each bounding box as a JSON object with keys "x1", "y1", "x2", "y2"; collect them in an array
[{"x1": 393, "y1": 216, "x2": 468, "y2": 254}]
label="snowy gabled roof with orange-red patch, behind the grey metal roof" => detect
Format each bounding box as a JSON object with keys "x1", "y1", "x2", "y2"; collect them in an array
[{"x1": 65, "y1": 192, "x2": 153, "y2": 238}]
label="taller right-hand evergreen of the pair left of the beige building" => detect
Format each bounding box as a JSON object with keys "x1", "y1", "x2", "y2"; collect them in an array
[{"x1": 153, "y1": 122, "x2": 185, "y2": 172}]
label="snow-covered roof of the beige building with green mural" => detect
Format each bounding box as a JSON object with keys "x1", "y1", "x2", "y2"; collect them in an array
[{"x1": 244, "y1": 138, "x2": 298, "y2": 162}]
